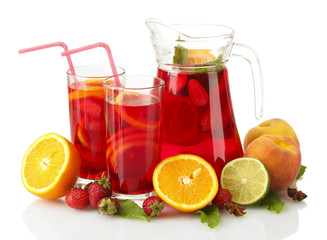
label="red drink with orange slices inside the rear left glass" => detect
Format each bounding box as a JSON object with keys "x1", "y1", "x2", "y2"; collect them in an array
[{"x1": 68, "y1": 81, "x2": 107, "y2": 180}]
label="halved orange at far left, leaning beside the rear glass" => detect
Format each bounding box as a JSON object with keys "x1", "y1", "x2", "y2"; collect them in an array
[{"x1": 21, "y1": 133, "x2": 81, "y2": 199}]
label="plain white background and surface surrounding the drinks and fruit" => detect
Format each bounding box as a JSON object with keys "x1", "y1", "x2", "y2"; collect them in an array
[{"x1": 0, "y1": 0, "x2": 327, "y2": 240}]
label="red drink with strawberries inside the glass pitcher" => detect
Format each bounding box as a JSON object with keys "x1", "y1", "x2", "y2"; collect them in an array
[{"x1": 157, "y1": 68, "x2": 243, "y2": 179}]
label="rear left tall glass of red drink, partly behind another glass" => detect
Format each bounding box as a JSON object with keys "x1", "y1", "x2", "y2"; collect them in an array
[{"x1": 67, "y1": 65, "x2": 125, "y2": 183}]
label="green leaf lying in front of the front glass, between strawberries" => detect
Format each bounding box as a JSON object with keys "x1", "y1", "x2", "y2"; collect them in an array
[{"x1": 116, "y1": 200, "x2": 150, "y2": 222}]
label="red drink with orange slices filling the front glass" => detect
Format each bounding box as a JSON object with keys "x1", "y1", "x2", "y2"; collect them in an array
[{"x1": 106, "y1": 94, "x2": 161, "y2": 194}]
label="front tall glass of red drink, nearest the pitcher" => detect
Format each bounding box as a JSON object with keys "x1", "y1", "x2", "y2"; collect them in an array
[{"x1": 104, "y1": 75, "x2": 164, "y2": 199}]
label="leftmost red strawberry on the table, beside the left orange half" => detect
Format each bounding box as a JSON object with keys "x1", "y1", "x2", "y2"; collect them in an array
[{"x1": 65, "y1": 188, "x2": 90, "y2": 210}]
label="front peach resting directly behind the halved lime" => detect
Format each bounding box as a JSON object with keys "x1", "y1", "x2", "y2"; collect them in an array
[{"x1": 244, "y1": 135, "x2": 301, "y2": 191}]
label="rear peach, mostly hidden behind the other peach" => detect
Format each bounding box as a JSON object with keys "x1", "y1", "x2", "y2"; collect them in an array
[{"x1": 243, "y1": 118, "x2": 300, "y2": 149}]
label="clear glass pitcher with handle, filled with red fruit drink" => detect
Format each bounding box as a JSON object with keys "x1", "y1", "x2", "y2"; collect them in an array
[{"x1": 146, "y1": 19, "x2": 263, "y2": 178}]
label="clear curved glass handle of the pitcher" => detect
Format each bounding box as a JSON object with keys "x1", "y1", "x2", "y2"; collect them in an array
[{"x1": 232, "y1": 43, "x2": 263, "y2": 120}]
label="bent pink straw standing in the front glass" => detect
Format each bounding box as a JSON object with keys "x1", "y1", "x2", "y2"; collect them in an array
[{"x1": 61, "y1": 42, "x2": 121, "y2": 87}]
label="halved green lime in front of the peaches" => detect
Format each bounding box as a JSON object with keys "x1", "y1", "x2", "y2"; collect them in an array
[{"x1": 221, "y1": 157, "x2": 269, "y2": 205}]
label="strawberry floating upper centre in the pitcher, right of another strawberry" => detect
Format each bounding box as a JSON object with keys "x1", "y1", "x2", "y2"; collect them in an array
[{"x1": 188, "y1": 79, "x2": 209, "y2": 107}]
